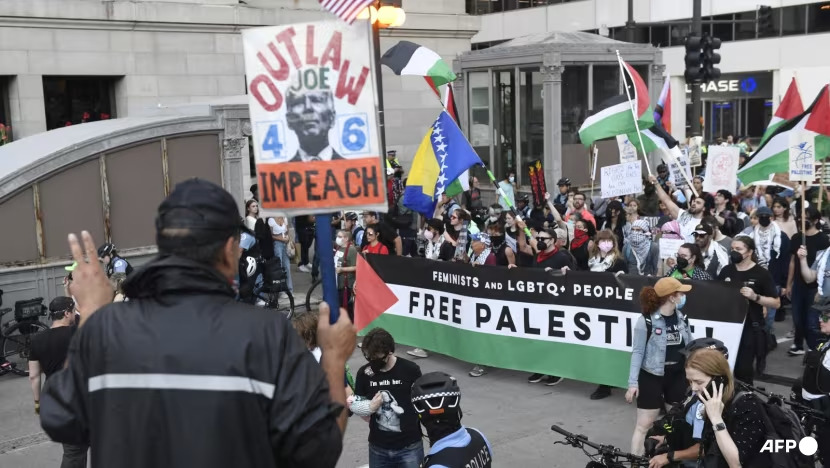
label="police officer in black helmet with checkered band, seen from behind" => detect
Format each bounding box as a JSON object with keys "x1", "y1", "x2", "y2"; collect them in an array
[{"x1": 412, "y1": 372, "x2": 493, "y2": 468}]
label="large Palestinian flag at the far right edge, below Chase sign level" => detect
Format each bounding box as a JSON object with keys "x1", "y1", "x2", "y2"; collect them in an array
[{"x1": 738, "y1": 85, "x2": 830, "y2": 185}]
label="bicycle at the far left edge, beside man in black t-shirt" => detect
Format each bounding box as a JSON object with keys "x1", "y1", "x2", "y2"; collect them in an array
[{"x1": 0, "y1": 291, "x2": 49, "y2": 377}]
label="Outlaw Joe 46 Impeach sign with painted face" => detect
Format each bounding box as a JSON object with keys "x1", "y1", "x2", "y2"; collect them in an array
[{"x1": 242, "y1": 21, "x2": 386, "y2": 215}]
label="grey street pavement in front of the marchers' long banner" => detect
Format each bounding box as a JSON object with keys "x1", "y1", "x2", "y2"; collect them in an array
[{"x1": 0, "y1": 268, "x2": 802, "y2": 468}]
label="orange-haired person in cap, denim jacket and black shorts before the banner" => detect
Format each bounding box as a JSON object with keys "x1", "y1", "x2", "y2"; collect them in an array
[{"x1": 625, "y1": 278, "x2": 692, "y2": 454}]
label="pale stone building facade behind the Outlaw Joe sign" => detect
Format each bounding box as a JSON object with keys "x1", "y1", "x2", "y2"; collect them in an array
[{"x1": 0, "y1": 0, "x2": 479, "y2": 176}]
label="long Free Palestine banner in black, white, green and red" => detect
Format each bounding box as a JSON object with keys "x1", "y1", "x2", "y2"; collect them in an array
[{"x1": 355, "y1": 255, "x2": 747, "y2": 387}]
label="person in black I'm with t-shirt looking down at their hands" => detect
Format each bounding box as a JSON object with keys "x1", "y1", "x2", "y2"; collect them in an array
[{"x1": 354, "y1": 328, "x2": 424, "y2": 468}]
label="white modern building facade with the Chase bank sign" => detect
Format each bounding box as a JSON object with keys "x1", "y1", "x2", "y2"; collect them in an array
[{"x1": 467, "y1": 0, "x2": 830, "y2": 141}]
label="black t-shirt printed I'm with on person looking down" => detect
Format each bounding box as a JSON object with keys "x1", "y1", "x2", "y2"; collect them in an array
[{"x1": 355, "y1": 357, "x2": 421, "y2": 450}]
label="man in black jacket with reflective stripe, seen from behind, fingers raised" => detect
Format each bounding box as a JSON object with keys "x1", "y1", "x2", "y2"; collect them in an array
[{"x1": 41, "y1": 179, "x2": 355, "y2": 468}]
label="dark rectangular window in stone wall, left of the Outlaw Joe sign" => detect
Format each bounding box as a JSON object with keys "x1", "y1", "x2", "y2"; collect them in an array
[{"x1": 43, "y1": 76, "x2": 118, "y2": 130}]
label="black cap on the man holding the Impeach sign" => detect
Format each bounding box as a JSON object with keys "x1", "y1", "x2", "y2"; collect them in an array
[{"x1": 156, "y1": 179, "x2": 240, "y2": 247}]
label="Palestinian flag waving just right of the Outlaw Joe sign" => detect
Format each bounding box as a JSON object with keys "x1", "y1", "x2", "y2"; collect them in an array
[{"x1": 380, "y1": 41, "x2": 457, "y2": 92}]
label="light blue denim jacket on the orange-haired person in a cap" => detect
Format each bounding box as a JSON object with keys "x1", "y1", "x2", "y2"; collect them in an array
[{"x1": 628, "y1": 310, "x2": 693, "y2": 388}]
